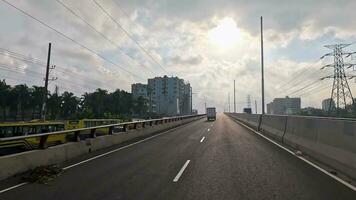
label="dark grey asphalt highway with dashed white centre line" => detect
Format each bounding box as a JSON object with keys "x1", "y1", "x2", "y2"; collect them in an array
[{"x1": 0, "y1": 114, "x2": 356, "y2": 200}]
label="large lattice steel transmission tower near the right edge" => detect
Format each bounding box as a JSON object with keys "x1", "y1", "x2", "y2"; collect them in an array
[{"x1": 320, "y1": 43, "x2": 356, "y2": 112}]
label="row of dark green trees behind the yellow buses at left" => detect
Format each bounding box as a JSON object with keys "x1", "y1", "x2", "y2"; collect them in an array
[{"x1": 0, "y1": 80, "x2": 148, "y2": 121}]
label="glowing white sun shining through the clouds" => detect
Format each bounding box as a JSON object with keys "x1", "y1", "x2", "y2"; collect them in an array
[{"x1": 208, "y1": 18, "x2": 241, "y2": 48}]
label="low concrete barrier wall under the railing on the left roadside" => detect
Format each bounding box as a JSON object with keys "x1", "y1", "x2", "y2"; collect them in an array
[{"x1": 0, "y1": 116, "x2": 203, "y2": 180}]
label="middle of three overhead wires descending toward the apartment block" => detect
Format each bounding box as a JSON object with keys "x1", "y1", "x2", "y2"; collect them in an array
[{"x1": 56, "y1": 0, "x2": 155, "y2": 74}]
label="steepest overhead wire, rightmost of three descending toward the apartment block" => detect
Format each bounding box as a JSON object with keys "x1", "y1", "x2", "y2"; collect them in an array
[{"x1": 93, "y1": 0, "x2": 169, "y2": 74}]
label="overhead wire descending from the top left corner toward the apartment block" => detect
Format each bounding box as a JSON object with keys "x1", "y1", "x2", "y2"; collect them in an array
[{"x1": 2, "y1": 0, "x2": 145, "y2": 80}]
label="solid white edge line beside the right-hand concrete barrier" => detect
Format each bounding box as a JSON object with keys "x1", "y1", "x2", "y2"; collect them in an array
[{"x1": 235, "y1": 120, "x2": 356, "y2": 191}]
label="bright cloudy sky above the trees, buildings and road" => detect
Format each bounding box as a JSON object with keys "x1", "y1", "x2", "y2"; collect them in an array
[{"x1": 0, "y1": 0, "x2": 356, "y2": 113}]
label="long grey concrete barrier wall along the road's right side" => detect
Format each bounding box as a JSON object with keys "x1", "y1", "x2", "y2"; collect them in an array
[{"x1": 228, "y1": 113, "x2": 356, "y2": 180}]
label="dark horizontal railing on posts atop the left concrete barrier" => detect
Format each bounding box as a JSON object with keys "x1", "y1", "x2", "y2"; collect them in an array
[{"x1": 0, "y1": 115, "x2": 204, "y2": 149}]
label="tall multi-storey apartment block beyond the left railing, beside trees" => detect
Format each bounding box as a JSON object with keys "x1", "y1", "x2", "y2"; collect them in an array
[{"x1": 132, "y1": 76, "x2": 191, "y2": 116}]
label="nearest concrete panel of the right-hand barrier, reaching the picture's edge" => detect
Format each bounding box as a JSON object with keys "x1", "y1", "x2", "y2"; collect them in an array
[{"x1": 284, "y1": 116, "x2": 356, "y2": 180}]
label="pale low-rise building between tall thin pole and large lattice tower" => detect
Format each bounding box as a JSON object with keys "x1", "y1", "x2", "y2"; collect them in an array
[{"x1": 267, "y1": 96, "x2": 301, "y2": 115}]
